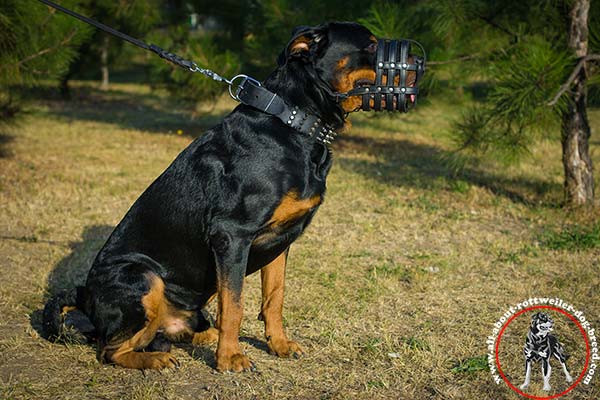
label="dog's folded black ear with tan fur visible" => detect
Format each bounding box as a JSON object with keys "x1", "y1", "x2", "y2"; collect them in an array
[{"x1": 277, "y1": 25, "x2": 327, "y2": 66}]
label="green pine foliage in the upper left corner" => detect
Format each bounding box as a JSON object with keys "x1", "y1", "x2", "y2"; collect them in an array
[{"x1": 0, "y1": 0, "x2": 90, "y2": 121}]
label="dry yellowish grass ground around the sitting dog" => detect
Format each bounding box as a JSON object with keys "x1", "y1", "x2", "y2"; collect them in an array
[{"x1": 0, "y1": 84, "x2": 600, "y2": 400}]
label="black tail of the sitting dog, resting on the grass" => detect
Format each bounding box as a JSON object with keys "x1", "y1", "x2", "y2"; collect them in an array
[{"x1": 43, "y1": 286, "x2": 86, "y2": 342}]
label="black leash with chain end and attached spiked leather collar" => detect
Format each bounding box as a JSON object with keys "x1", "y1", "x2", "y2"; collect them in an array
[{"x1": 39, "y1": 0, "x2": 336, "y2": 144}]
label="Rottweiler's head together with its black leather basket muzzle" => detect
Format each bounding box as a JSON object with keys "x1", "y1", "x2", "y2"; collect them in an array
[{"x1": 278, "y1": 22, "x2": 424, "y2": 112}]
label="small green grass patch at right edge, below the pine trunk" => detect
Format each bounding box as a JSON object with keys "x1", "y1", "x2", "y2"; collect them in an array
[{"x1": 540, "y1": 223, "x2": 600, "y2": 251}]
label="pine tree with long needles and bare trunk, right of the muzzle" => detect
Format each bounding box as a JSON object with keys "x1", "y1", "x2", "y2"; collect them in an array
[{"x1": 432, "y1": 0, "x2": 600, "y2": 205}]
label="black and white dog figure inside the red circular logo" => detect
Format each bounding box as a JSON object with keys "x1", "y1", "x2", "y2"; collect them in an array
[{"x1": 520, "y1": 312, "x2": 573, "y2": 391}]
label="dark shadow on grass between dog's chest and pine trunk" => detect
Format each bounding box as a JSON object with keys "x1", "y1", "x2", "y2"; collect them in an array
[{"x1": 336, "y1": 132, "x2": 561, "y2": 206}]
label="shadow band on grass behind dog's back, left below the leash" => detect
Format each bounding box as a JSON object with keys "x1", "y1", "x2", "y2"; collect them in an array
[{"x1": 18, "y1": 86, "x2": 228, "y2": 137}]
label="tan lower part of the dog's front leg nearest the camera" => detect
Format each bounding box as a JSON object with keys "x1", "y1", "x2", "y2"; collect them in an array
[{"x1": 217, "y1": 282, "x2": 251, "y2": 372}]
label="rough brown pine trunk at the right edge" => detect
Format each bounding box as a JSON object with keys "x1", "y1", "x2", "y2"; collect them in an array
[{"x1": 562, "y1": 0, "x2": 594, "y2": 206}]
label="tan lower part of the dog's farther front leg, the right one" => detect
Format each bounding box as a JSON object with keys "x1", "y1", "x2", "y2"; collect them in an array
[{"x1": 260, "y1": 252, "x2": 303, "y2": 357}]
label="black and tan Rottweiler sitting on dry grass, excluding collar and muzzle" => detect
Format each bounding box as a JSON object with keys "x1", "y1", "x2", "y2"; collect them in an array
[{"x1": 44, "y1": 23, "x2": 416, "y2": 371}]
